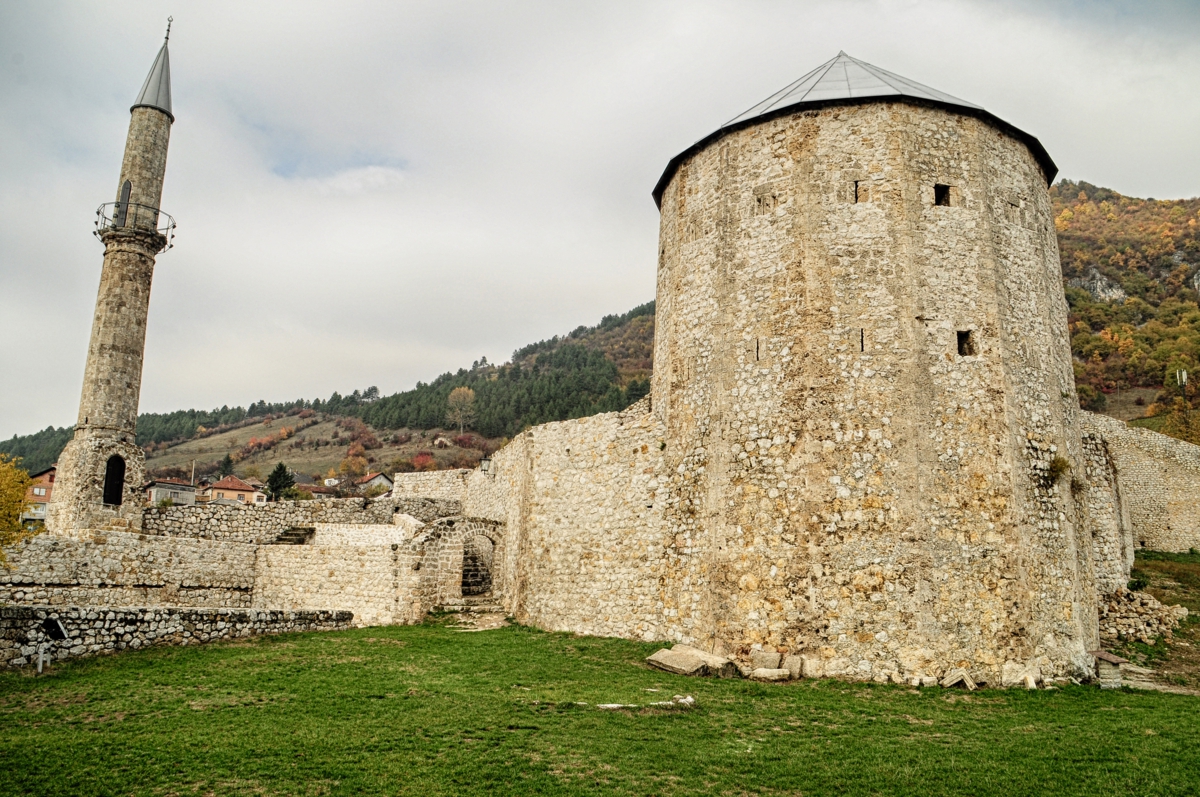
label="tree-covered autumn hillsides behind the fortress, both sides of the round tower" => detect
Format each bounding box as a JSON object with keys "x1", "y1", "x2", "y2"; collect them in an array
[{"x1": 9, "y1": 180, "x2": 1200, "y2": 471}]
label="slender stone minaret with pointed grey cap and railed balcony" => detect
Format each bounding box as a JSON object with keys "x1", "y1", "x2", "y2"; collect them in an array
[{"x1": 46, "y1": 19, "x2": 175, "y2": 533}]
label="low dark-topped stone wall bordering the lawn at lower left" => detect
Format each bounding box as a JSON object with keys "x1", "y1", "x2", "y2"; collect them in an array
[{"x1": 0, "y1": 606, "x2": 350, "y2": 667}]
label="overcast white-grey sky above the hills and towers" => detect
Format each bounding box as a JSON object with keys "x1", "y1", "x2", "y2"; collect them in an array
[{"x1": 0, "y1": 0, "x2": 1200, "y2": 437}]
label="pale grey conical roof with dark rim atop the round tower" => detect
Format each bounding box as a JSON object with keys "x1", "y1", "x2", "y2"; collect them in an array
[{"x1": 654, "y1": 52, "x2": 1058, "y2": 204}]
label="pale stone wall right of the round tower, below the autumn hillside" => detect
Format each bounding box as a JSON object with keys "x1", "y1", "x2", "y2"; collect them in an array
[{"x1": 1082, "y1": 413, "x2": 1200, "y2": 552}]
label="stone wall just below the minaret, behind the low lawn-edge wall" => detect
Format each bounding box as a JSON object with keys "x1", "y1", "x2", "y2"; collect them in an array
[{"x1": 0, "y1": 532, "x2": 256, "y2": 609}]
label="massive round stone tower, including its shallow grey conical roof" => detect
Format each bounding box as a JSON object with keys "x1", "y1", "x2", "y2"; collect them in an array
[{"x1": 652, "y1": 54, "x2": 1098, "y2": 683}]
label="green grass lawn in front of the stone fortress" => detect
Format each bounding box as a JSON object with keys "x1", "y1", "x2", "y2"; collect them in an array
[{"x1": 0, "y1": 619, "x2": 1200, "y2": 797}]
